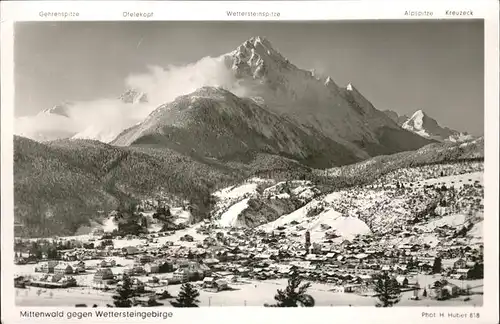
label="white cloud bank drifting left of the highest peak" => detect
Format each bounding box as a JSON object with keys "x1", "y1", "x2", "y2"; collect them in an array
[{"x1": 15, "y1": 57, "x2": 245, "y2": 142}]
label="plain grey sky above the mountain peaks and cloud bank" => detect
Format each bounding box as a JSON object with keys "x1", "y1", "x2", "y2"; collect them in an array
[{"x1": 14, "y1": 20, "x2": 484, "y2": 135}]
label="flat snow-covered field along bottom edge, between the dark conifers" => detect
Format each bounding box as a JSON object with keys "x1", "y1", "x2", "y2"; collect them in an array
[{"x1": 16, "y1": 275, "x2": 483, "y2": 307}]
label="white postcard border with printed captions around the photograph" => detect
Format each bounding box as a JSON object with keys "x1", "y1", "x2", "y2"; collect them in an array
[{"x1": 0, "y1": 0, "x2": 499, "y2": 324}]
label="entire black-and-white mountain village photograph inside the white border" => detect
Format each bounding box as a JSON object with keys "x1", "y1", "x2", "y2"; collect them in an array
[{"x1": 8, "y1": 19, "x2": 488, "y2": 308}]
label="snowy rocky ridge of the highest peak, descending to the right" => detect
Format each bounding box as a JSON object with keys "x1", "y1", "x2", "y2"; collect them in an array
[{"x1": 222, "y1": 37, "x2": 406, "y2": 146}]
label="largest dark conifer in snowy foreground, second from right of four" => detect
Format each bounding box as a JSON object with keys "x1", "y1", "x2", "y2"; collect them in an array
[{"x1": 274, "y1": 268, "x2": 314, "y2": 307}]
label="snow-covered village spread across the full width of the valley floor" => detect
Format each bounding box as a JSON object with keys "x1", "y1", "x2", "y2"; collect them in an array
[{"x1": 15, "y1": 221, "x2": 483, "y2": 308}]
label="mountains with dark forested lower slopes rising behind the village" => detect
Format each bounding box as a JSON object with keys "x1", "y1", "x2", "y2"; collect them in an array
[{"x1": 10, "y1": 37, "x2": 481, "y2": 236}]
